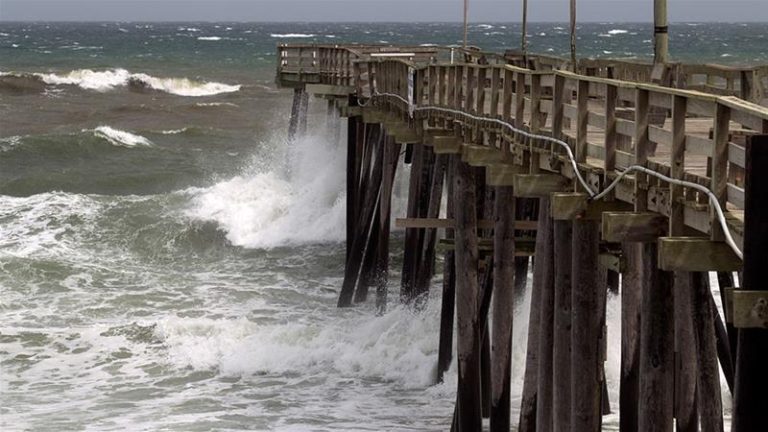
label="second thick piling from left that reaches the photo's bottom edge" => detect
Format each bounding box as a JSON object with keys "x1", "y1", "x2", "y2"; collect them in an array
[{"x1": 490, "y1": 186, "x2": 519, "y2": 432}]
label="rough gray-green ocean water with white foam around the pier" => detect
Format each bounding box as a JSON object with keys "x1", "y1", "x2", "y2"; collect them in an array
[{"x1": 0, "y1": 22, "x2": 756, "y2": 431}]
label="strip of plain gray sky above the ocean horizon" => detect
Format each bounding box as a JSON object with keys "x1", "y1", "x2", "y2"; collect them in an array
[{"x1": 0, "y1": 0, "x2": 768, "y2": 22}]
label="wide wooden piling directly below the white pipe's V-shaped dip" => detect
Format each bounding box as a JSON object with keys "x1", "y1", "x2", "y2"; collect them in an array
[{"x1": 571, "y1": 219, "x2": 605, "y2": 432}]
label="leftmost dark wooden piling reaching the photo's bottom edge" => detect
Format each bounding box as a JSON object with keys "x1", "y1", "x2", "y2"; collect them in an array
[{"x1": 453, "y1": 158, "x2": 482, "y2": 432}]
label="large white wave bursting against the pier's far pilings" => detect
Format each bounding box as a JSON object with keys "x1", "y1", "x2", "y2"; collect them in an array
[{"x1": 187, "y1": 137, "x2": 346, "y2": 249}]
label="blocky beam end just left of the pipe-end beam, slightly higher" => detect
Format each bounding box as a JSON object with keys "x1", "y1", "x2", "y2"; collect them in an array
[{"x1": 603, "y1": 212, "x2": 669, "y2": 243}]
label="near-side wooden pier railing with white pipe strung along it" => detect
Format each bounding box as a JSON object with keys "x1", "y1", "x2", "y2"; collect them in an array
[{"x1": 279, "y1": 45, "x2": 768, "y2": 251}]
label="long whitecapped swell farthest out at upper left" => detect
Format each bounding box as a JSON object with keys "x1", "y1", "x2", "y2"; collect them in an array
[{"x1": 0, "y1": 69, "x2": 241, "y2": 97}]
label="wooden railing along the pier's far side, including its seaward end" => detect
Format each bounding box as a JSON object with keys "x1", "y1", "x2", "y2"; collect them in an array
[{"x1": 278, "y1": 44, "x2": 768, "y2": 105}]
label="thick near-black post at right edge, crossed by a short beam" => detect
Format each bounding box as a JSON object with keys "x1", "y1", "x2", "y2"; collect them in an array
[{"x1": 732, "y1": 135, "x2": 768, "y2": 432}]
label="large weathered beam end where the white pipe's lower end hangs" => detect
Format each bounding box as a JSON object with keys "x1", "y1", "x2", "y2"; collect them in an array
[{"x1": 659, "y1": 237, "x2": 742, "y2": 272}]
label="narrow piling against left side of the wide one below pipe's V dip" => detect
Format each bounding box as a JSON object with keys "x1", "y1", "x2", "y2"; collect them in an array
[{"x1": 552, "y1": 220, "x2": 573, "y2": 431}]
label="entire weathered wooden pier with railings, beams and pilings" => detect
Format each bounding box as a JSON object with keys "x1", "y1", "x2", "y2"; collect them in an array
[{"x1": 277, "y1": 44, "x2": 768, "y2": 432}]
